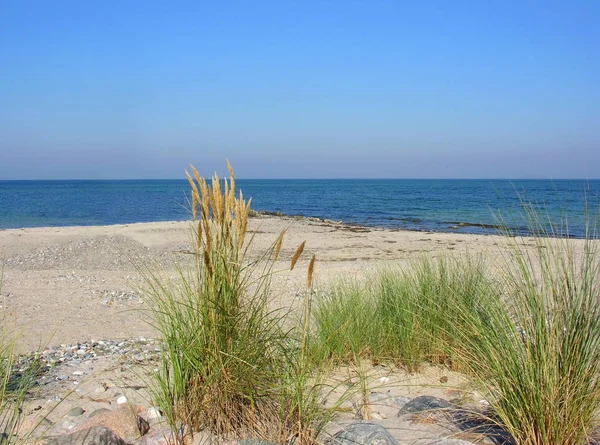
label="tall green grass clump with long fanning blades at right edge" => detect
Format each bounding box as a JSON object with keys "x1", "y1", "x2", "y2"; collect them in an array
[{"x1": 456, "y1": 205, "x2": 600, "y2": 445}]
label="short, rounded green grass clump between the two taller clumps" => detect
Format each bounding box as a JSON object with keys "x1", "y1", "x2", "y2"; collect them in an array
[{"x1": 313, "y1": 253, "x2": 492, "y2": 371}]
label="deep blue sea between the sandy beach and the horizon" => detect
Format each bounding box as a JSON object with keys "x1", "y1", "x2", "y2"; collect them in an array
[{"x1": 0, "y1": 179, "x2": 600, "y2": 237}]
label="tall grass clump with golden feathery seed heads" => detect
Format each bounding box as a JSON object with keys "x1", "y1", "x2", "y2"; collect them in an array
[{"x1": 144, "y1": 164, "x2": 336, "y2": 445}]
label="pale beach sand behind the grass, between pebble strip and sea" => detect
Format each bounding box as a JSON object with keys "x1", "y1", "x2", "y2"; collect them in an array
[{"x1": 0, "y1": 217, "x2": 505, "y2": 351}]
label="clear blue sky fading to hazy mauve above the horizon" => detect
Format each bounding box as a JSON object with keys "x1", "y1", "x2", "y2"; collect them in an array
[{"x1": 0, "y1": 0, "x2": 600, "y2": 179}]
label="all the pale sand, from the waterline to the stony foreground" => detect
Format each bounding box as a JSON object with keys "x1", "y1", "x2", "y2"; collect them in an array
[{"x1": 0, "y1": 217, "x2": 576, "y2": 445}]
